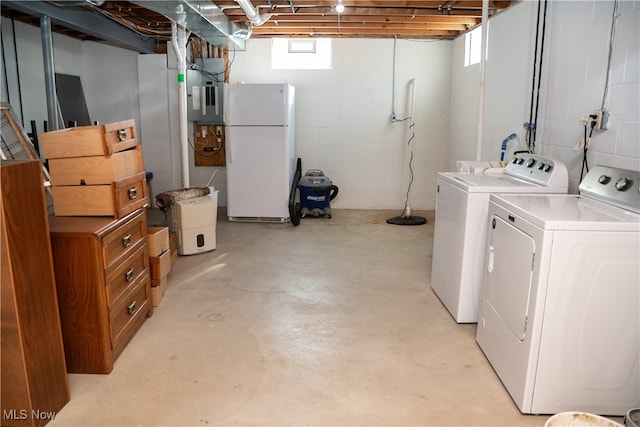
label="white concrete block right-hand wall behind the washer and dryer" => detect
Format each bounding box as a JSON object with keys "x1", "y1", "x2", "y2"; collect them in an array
[{"x1": 446, "y1": 0, "x2": 640, "y2": 193}]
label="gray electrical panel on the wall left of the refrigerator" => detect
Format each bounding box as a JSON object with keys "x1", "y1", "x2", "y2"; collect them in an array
[{"x1": 187, "y1": 58, "x2": 224, "y2": 125}]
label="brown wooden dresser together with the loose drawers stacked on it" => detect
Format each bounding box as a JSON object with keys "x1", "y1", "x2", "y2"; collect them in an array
[{"x1": 40, "y1": 120, "x2": 153, "y2": 373}]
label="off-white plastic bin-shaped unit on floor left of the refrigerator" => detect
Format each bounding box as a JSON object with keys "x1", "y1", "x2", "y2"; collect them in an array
[{"x1": 172, "y1": 196, "x2": 218, "y2": 255}]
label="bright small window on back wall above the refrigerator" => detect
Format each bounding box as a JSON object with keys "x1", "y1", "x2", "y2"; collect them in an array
[{"x1": 271, "y1": 39, "x2": 333, "y2": 70}]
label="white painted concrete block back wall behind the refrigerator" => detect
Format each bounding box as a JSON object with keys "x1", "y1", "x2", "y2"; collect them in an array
[{"x1": 191, "y1": 39, "x2": 451, "y2": 210}]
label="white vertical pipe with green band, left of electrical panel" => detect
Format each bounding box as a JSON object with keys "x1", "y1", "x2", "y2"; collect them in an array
[{"x1": 171, "y1": 22, "x2": 189, "y2": 188}]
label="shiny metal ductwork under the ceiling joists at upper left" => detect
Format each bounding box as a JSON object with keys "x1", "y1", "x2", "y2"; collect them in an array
[{"x1": 131, "y1": 0, "x2": 251, "y2": 50}]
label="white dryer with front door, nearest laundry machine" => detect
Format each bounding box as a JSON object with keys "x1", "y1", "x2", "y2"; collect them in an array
[{"x1": 476, "y1": 167, "x2": 640, "y2": 416}]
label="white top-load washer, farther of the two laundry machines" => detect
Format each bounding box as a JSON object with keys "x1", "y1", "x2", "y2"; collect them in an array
[{"x1": 431, "y1": 154, "x2": 569, "y2": 323}]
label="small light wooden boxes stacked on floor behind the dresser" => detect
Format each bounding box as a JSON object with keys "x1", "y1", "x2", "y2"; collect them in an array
[{"x1": 147, "y1": 227, "x2": 171, "y2": 307}]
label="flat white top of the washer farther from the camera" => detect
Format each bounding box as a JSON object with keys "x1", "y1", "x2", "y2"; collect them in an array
[{"x1": 438, "y1": 172, "x2": 567, "y2": 193}]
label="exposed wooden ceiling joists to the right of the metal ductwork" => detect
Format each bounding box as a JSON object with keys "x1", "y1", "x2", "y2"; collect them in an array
[{"x1": 215, "y1": 0, "x2": 517, "y2": 40}]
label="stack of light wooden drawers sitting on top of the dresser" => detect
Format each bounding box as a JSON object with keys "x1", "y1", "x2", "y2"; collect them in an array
[{"x1": 40, "y1": 120, "x2": 148, "y2": 218}]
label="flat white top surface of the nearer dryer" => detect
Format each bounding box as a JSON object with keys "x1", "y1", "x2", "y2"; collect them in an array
[{"x1": 489, "y1": 194, "x2": 640, "y2": 232}]
